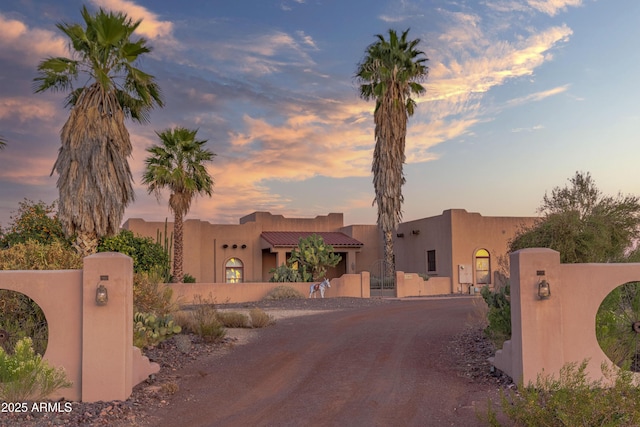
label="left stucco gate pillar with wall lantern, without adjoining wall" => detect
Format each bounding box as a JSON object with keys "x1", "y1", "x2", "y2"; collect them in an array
[{"x1": 82, "y1": 252, "x2": 133, "y2": 402}]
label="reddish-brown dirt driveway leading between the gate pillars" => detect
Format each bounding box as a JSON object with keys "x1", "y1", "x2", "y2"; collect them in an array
[{"x1": 149, "y1": 298, "x2": 497, "y2": 427}]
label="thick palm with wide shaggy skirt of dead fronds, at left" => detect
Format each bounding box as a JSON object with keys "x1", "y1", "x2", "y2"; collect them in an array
[{"x1": 34, "y1": 7, "x2": 163, "y2": 255}]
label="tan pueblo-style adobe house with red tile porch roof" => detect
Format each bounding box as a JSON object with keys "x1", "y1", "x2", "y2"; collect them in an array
[{"x1": 124, "y1": 209, "x2": 535, "y2": 293}]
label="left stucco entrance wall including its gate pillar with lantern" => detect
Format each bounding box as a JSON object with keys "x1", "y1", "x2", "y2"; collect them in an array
[{"x1": 0, "y1": 252, "x2": 160, "y2": 402}]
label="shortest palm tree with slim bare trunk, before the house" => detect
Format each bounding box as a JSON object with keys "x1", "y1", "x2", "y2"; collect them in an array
[{"x1": 142, "y1": 127, "x2": 215, "y2": 283}]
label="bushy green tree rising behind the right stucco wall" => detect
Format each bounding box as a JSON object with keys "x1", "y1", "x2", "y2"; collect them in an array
[{"x1": 510, "y1": 172, "x2": 640, "y2": 263}]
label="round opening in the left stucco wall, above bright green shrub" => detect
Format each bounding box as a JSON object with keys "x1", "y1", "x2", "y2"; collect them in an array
[{"x1": 0, "y1": 289, "x2": 49, "y2": 356}]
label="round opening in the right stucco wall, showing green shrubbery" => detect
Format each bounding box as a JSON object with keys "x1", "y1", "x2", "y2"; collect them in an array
[{"x1": 596, "y1": 282, "x2": 640, "y2": 372}]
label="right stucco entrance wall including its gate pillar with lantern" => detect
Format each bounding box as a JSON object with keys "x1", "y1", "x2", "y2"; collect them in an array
[{"x1": 493, "y1": 249, "x2": 640, "y2": 384}]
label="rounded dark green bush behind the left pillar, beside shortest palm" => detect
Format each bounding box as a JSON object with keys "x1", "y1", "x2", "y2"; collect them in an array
[{"x1": 98, "y1": 230, "x2": 169, "y2": 273}]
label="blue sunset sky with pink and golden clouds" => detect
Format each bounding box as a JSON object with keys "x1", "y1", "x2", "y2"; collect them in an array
[{"x1": 0, "y1": 0, "x2": 640, "y2": 226}]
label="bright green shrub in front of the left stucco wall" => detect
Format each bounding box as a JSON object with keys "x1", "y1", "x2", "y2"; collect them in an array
[{"x1": 0, "y1": 338, "x2": 72, "y2": 402}]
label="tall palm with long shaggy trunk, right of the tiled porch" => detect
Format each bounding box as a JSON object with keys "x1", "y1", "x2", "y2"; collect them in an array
[{"x1": 356, "y1": 29, "x2": 428, "y2": 273}]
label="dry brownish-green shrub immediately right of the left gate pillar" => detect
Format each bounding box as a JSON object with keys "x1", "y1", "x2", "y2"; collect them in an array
[{"x1": 133, "y1": 270, "x2": 178, "y2": 316}]
